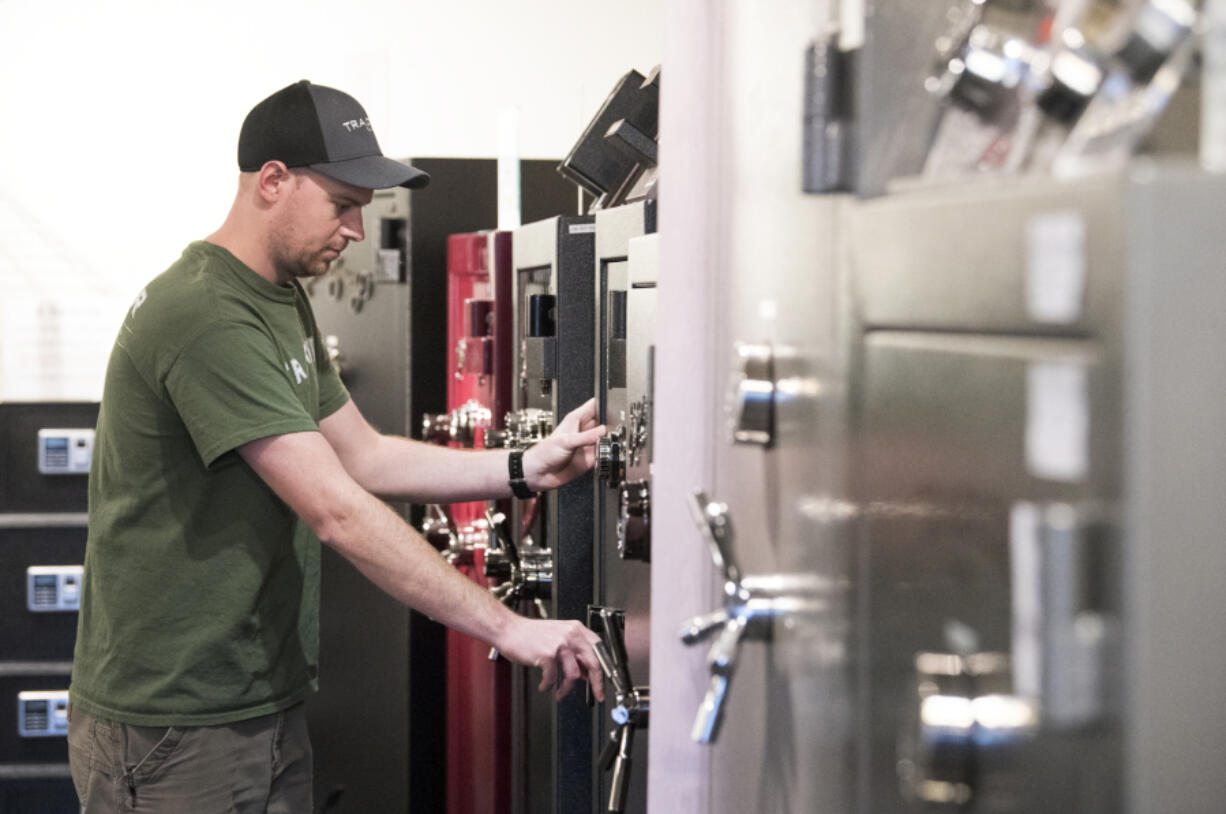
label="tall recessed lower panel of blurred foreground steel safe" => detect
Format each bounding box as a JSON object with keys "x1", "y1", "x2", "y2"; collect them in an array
[{"x1": 852, "y1": 332, "x2": 1122, "y2": 813}]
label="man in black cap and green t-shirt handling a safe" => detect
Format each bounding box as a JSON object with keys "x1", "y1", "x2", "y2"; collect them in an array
[{"x1": 69, "y1": 81, "x2": 604, "y2": 814}]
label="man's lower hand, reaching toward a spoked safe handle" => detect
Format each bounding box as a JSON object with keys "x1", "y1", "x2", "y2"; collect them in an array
[{"x1": 492, "y1": 617, "x2": 604, "y2": 701}]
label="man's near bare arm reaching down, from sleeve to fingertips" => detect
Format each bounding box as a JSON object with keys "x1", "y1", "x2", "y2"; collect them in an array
[{"x1": 238, "y1": 430, "x2": 603, "y2": 699}]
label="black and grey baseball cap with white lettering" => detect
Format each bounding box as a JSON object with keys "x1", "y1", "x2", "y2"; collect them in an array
[{"x1": 238, "y1": 80, "x2": 430, "y2": 189}]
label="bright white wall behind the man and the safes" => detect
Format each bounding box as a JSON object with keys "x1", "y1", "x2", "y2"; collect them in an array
[{"x1": 0, "y1": 0, "x2": 663, "y2": 398}]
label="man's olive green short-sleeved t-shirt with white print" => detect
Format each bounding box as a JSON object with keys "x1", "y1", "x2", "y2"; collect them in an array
[{"x1": 70, "y1": 242, "x2": 348, "y2": 726}]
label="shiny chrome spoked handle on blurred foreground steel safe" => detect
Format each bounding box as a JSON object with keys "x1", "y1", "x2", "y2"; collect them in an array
[{"x1": 680, "y1": 492, "x2": 829, "y2": 743}]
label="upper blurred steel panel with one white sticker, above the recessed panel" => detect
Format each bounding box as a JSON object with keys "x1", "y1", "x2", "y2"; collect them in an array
[{"x1": 850, "y1": 175, "x2": 1124, "y2": 336}]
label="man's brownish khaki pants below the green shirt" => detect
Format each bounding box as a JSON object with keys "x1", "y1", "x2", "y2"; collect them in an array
[{"x1": 69, "y1": 704, "x2": 313, "y2": 814}]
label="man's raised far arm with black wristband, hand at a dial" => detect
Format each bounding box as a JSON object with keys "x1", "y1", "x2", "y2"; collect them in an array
[{"x1": 319, "y1": 400, "x2": 604, "y2": 503}]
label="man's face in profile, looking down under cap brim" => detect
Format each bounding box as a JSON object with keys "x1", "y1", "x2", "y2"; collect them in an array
[{"x1": 270, "y1": 169, "x2": 373, "y2": 282}]
